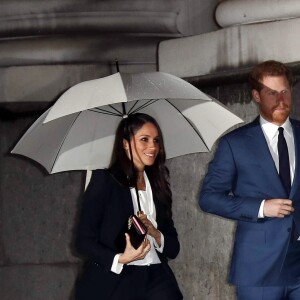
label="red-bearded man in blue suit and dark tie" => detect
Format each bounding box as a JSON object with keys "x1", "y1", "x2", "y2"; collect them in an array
[{"x1": 199, "y1": 61, "x2": 300, "y2": 300}]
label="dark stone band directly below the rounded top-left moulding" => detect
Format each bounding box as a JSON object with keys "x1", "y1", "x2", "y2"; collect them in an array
[{"x1": 0, "y1": 34, "x2": 165, "y2": 67}]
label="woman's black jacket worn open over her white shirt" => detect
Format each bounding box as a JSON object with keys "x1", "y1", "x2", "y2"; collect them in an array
[{"x1": 76, "y1": 170, "x2": 180, "y2": 299}]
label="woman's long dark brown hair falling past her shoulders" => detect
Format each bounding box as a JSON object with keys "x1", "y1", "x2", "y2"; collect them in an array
[{"x1": 110, "y1": 113, "x2": 172, "y2": 217}]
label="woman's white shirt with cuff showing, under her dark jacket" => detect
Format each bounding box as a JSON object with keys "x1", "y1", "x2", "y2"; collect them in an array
[{"x1": 111, "y1": 172, "x2": 164, "y2": 274}]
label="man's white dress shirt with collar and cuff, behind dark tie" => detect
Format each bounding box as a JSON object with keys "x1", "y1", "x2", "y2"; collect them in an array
[{"x1": 258, "y1": 116, "x2": 295, "y2": 218}]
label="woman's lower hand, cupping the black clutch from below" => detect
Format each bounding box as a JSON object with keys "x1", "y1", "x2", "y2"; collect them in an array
[{"x1": 119, "y1": 233, "x2": 151, "y2": 264}]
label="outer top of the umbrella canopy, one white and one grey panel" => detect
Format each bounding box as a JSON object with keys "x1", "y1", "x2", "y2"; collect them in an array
[{"x1": 45, "y1": 72, "x2": 211, "y2": 122}]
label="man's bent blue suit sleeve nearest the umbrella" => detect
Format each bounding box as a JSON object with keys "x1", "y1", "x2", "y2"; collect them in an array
[{"x1": 199, "y1": 136, "x2": 263, "y2": 222}]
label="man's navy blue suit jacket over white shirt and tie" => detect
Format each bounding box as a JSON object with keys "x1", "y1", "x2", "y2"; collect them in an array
[{"x1": 199, "y1": 118, "x2": 300, "y2": 286}]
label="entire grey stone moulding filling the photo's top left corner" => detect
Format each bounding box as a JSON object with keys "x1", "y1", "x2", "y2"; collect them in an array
[{"x1": 0, "y1": 0, "x2": 181, "y2": 37}]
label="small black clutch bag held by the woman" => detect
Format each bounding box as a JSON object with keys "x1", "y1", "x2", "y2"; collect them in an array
[{"x1": 127, "y1": 215, "x2": 147, "y2": 249}]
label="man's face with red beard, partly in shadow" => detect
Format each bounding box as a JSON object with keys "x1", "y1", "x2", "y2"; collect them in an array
[{"x1": 252, "y1": 76, "x2": 292, "y2": 126}]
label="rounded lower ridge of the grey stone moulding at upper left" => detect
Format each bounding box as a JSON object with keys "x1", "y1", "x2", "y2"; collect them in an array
[{"x1": 0, "y1": 12, "x2": 180, "y2": 37}]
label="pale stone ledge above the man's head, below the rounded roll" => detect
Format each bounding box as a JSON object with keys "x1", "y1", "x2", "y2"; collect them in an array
[{"x1": 159, "y1": 18, "x2": 300, "y2": 78}]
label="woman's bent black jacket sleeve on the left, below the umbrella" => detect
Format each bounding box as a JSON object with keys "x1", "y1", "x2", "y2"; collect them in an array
[{"x1": 75, "y1": 170, "x2": 117, "y2": 270}]
